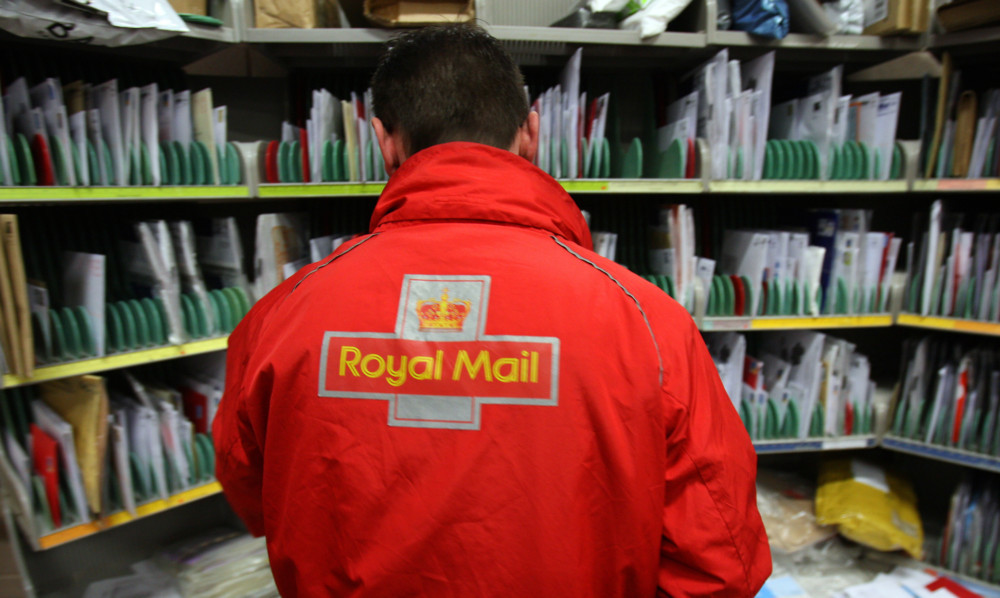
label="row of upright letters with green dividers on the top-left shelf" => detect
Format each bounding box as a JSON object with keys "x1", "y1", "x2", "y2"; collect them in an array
[{"x1": 0, "y1": 77, "x2": 243, "y2": 186}]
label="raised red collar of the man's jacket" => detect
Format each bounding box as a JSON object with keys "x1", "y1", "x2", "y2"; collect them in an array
[{"x1": 371, "y1": 141, "x2": 593, "y2": 249}]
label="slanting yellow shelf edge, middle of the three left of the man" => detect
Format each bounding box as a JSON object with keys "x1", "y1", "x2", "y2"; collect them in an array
[{"x1": 3, "y1": 336, "x2": 229, "y2": 388}]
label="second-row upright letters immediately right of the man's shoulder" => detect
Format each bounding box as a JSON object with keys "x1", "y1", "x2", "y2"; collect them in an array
[{"x1": 647, "y1": 205, "x2": 902, "y2": 317}]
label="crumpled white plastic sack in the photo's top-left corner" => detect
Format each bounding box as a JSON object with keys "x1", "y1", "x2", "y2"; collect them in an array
[{"x1": 0, "y1": 0, "x2": 188, "y2": 46}]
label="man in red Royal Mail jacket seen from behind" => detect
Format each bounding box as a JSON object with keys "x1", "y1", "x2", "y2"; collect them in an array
[{"x1": 214, "y1": 26, "x2": 771, "y2": 598}]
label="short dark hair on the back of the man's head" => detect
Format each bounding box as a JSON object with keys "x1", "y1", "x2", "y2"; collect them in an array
[{"x1": 371, "y1": 25, "x2": 528, "y2": 155}]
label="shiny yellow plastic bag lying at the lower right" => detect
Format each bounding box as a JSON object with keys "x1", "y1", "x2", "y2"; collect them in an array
[{"x1": 816, "y1": 459, "x2": 924, "y2": 559}]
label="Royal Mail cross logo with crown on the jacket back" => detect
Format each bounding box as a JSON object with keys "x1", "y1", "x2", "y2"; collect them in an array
[{"x1": 319, "y1": 274, "x2": 559, "y2": 430}]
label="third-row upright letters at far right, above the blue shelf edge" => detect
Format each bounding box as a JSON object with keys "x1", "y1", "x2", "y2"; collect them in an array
[{"x1": 891, "y1": 337, "x2": 1000, "y2": 456}]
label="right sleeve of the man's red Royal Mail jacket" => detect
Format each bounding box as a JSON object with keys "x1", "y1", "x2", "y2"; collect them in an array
[{"x1": 658, "y1": 314, "x2": 771, "y2": 598}]
